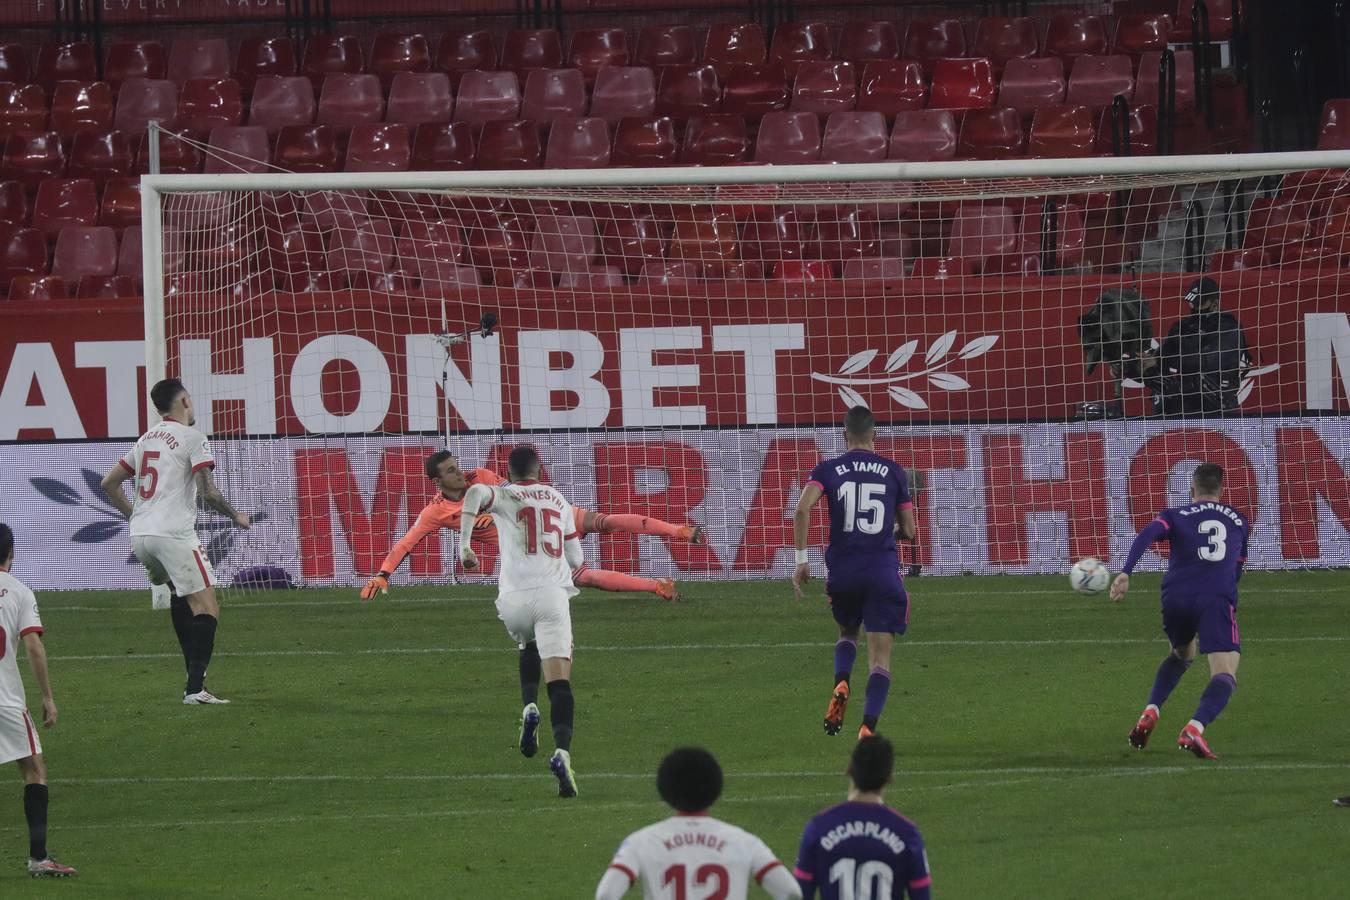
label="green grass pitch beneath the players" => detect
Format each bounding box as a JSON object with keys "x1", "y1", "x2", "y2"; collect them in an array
[{"x1": 0, "y1": 574, "x2": 1350, "y2": 900}]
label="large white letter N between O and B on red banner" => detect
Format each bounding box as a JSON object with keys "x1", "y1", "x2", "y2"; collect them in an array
[{"x1": 404, "y1": 335, "x2": 502, "y2": 432}]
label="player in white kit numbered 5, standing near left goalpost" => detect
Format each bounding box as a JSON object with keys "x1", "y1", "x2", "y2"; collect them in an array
[{"x1": 103, "y1": 378, "x2": 250, "y2": 706}]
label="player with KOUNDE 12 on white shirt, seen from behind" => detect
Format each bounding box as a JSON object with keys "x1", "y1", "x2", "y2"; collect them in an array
[{"x1": 595, "y1": 748, "x2": 802, "y2": 900}]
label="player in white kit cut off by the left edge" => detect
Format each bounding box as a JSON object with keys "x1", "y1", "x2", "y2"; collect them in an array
[{"x1": 0, "y1": 522, "x2": 76, "y2": 878}]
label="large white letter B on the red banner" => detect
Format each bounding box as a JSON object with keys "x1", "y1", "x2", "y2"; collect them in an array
[{"x1": 517, "y1": 331, "x2": 610, "y2": 428}]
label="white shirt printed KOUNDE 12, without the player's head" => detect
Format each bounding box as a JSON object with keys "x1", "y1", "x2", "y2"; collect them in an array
[{"x1": 597, "y1": 815, "x2": 801, "y2": 900}]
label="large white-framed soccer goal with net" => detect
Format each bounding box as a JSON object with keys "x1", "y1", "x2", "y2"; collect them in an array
[{"x1": 143, "y1": 148, "x2": 1350, "y2": 584}]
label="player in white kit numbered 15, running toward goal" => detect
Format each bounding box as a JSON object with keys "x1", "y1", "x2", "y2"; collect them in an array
[{"x1": 459, "y1": 447, "x2": 582, "y2": 797}]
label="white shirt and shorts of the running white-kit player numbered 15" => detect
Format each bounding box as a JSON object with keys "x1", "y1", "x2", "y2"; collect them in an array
[{"x1": 460, "y1": 482, "x2": 582, "y2": 660}]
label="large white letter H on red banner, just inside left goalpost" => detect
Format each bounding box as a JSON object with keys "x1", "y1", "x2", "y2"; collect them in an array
[{"x1": 178, "y1": 337, "x2": 277, "y2": 434}]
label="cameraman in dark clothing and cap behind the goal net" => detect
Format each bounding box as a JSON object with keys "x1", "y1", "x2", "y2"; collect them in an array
[{"x1": 1141, "y1": 278, "x2": 1251, "y2": 417}]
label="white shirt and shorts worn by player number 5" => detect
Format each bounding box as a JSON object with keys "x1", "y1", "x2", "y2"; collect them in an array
[{"x1": 120, "y1": 418, "x2": 216, "y2": 596}]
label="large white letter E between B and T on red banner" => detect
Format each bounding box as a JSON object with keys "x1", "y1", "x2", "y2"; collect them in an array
[{"x1": 618, "y1": 325, "x2": 707, "y2": 428}]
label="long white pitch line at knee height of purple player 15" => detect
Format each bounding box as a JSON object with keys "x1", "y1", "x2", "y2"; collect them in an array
[{"x1": 47, "y1": 634, "x2": 1350, "y2": 663}]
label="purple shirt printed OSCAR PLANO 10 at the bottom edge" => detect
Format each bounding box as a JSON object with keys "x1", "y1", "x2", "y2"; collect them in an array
[{"x1": 794, "y1": 803, "x2": 933, "y2": 900}]
